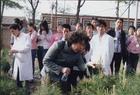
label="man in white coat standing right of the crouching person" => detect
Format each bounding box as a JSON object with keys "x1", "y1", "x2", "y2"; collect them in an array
[{"x1": 87, "y1": 20, "x2": 114, "y2": 75}]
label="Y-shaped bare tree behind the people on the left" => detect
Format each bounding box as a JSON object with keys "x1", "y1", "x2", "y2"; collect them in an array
[{"x1": 28, "y1": 0, "x2": 39, "y2": 24}]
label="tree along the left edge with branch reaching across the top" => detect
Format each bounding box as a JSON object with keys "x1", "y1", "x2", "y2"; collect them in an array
[{"x1": 0, "y1": 0, "x2": 22, "y2": 75}]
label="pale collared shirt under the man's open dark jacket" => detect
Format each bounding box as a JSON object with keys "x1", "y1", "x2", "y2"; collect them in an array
[{"x1": 114, "y1": 29, "x2": 121, "y2": 53}]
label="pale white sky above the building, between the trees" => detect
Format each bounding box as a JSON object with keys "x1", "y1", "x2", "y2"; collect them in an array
[{"x1": 4, "y1": 0, "x2": 140, "y2": 19}]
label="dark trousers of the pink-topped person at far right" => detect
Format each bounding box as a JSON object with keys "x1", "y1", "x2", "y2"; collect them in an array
[{"x1": 127, "y1": 53, "x2": 139, "y2": 73}]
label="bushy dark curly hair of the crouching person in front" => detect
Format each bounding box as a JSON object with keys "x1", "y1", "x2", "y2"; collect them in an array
[{"x1": 67, "y1": 32, "x2": 89, "y2": 48}]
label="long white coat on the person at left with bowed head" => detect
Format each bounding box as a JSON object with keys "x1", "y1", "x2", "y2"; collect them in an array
[{"x1": 11, "y1": 32, "x2": 33, "y2": 81}]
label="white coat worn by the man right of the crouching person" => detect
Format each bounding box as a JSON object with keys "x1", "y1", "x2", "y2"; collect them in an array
[{"x1": 86, "y1": 33, "x2": 114, "y2": 75}]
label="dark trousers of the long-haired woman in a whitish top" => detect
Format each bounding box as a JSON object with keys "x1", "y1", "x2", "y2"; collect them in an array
[{"x1": 37, "y1": 46, "x2": 48, "y2": 71}]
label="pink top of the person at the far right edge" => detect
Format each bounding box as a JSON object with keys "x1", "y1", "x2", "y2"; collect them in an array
[{"x1": 127, "y1": 36, "x2": 140, "y2": 54}]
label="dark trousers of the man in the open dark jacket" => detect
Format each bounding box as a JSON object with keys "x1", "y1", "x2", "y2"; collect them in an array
[{"x1": 110, "y1": 53, "x2": 122, "y2": 74}]
